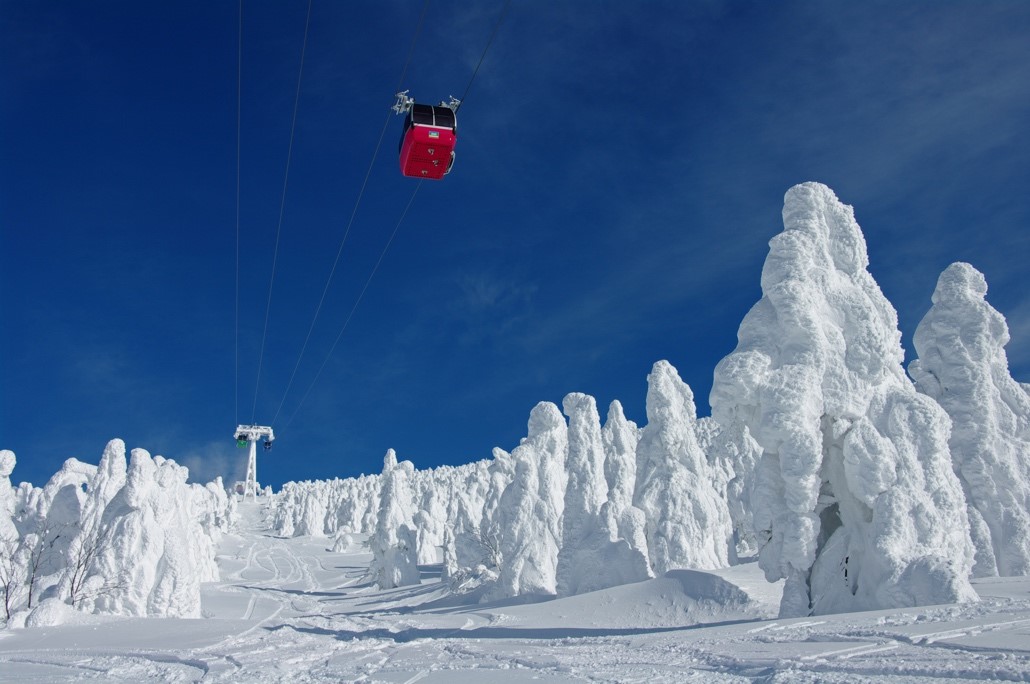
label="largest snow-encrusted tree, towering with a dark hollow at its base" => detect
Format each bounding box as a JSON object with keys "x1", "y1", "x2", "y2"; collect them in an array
[{"x1": 712, "y1": 183, "x2": 975, "y2": 616}]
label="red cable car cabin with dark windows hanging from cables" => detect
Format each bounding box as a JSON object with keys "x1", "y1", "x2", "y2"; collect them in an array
[{"x1": 401, "y1": 104, "x2": 457, "y2": 180}]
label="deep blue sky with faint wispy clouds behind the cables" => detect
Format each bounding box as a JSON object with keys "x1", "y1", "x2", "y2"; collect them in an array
[{"x1": 0, "y1": 0, "x2": 1030, "y2": 486}]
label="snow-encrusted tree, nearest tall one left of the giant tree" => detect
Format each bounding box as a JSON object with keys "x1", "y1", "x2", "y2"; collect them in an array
[{"x1": 633, "y1": 361, "x2": 732, "y2": 576}]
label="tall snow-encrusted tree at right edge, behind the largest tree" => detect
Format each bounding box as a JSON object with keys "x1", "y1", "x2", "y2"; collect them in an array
[{"x1": 908, "y1": 263, "x2": 1030, "y2": 577}]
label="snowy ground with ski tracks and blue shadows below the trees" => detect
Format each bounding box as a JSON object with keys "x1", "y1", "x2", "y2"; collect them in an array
[{"x1": 0, "y1": 505, "x2": 1030, "y2": 684}]
